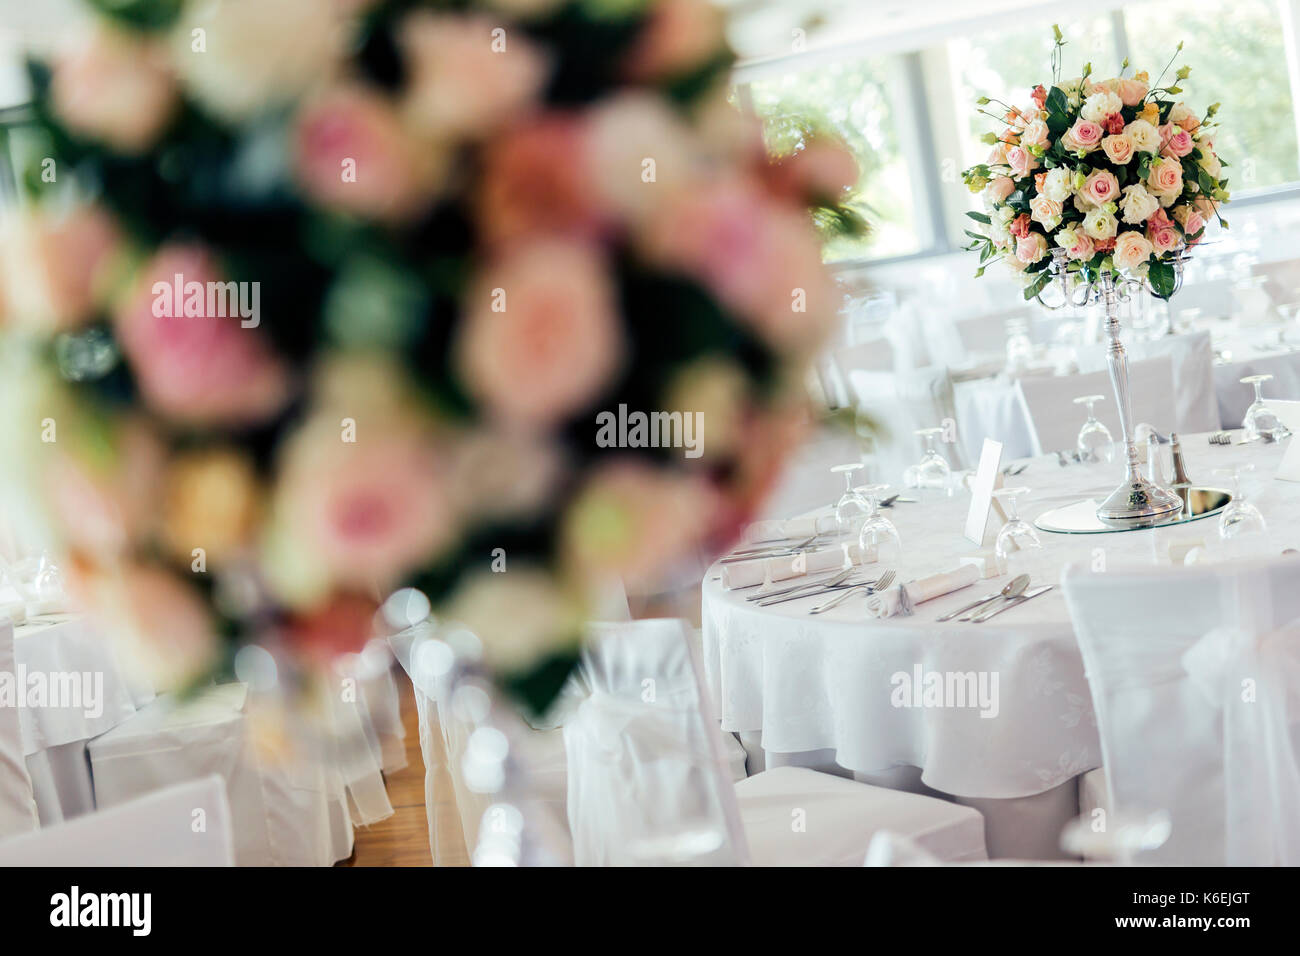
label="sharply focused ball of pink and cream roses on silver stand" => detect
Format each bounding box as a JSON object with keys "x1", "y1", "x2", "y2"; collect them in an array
[{"x1": 962, "y1": 27, "x2": 1230, "y2": 299}]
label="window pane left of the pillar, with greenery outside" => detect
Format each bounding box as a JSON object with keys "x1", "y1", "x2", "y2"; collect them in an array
[{"x1": 749, "y1": 59, "x2": 922, "y2": 261}]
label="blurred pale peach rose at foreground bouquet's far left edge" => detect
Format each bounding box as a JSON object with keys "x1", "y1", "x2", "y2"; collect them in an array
[{"x1": 0, "y1": 206, "x2": 122, "y2": 330}]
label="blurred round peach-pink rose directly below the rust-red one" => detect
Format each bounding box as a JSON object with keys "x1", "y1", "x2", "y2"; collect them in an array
[{"x1": 455, "y1": 239, "x2": 623, "y2": 428}]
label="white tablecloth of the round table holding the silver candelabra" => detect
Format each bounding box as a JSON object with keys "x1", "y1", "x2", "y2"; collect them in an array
[{"x1": 702, "y1": 432, "x2": 1300, "y2": 851}]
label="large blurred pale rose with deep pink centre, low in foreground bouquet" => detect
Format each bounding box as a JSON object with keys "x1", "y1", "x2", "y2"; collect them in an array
[{"x1": 273, "y1": 415, "x2": 456, "y2": 592}]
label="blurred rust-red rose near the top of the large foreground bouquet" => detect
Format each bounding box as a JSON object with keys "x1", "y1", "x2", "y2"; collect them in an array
[{"x1": 478, "y1": 113, "x2": 610, "y2": 245}]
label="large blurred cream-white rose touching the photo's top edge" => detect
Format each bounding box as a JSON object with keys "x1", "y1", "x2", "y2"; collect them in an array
[{"x1": 172, "y1": 0, "x2": 345, "y2": 122}]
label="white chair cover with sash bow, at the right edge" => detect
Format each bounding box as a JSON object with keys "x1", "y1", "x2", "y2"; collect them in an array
[{"x1": 1063, "y1": 558, "x2": 1300, "y2": 866}]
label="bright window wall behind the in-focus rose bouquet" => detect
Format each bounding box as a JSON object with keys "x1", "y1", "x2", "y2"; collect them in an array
[{"x1": 738, "y1": 0, "x2": 1300, "y2": 261}]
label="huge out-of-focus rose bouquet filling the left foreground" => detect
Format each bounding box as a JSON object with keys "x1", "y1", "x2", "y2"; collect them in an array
[{"x1": 0, "y1": 0, "x2": 857, "y2": 709}]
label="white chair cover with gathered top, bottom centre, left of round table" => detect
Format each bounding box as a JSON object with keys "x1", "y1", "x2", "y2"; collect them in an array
[{"x1": 564, "y1": 620, "x2": 749, "y2": 866}]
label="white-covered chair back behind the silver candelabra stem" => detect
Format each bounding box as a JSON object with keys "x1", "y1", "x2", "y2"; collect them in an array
[{"x1": 1017, "y1": 355, "x2": 1178, "y2": 455}]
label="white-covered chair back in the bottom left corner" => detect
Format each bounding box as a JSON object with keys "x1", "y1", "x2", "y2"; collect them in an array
[{"x1": 0, "y1": 774, "x2": 235, "y2": 866}]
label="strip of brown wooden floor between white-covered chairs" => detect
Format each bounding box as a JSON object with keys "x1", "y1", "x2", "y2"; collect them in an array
[{"x1": 338, "y1": 674, "x2": 469, "y2": 866}]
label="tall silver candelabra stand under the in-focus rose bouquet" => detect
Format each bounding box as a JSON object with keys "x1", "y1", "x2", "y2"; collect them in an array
[{"x1": 1036, "y1": 248, "x2": 1188, "y2": 528}]
